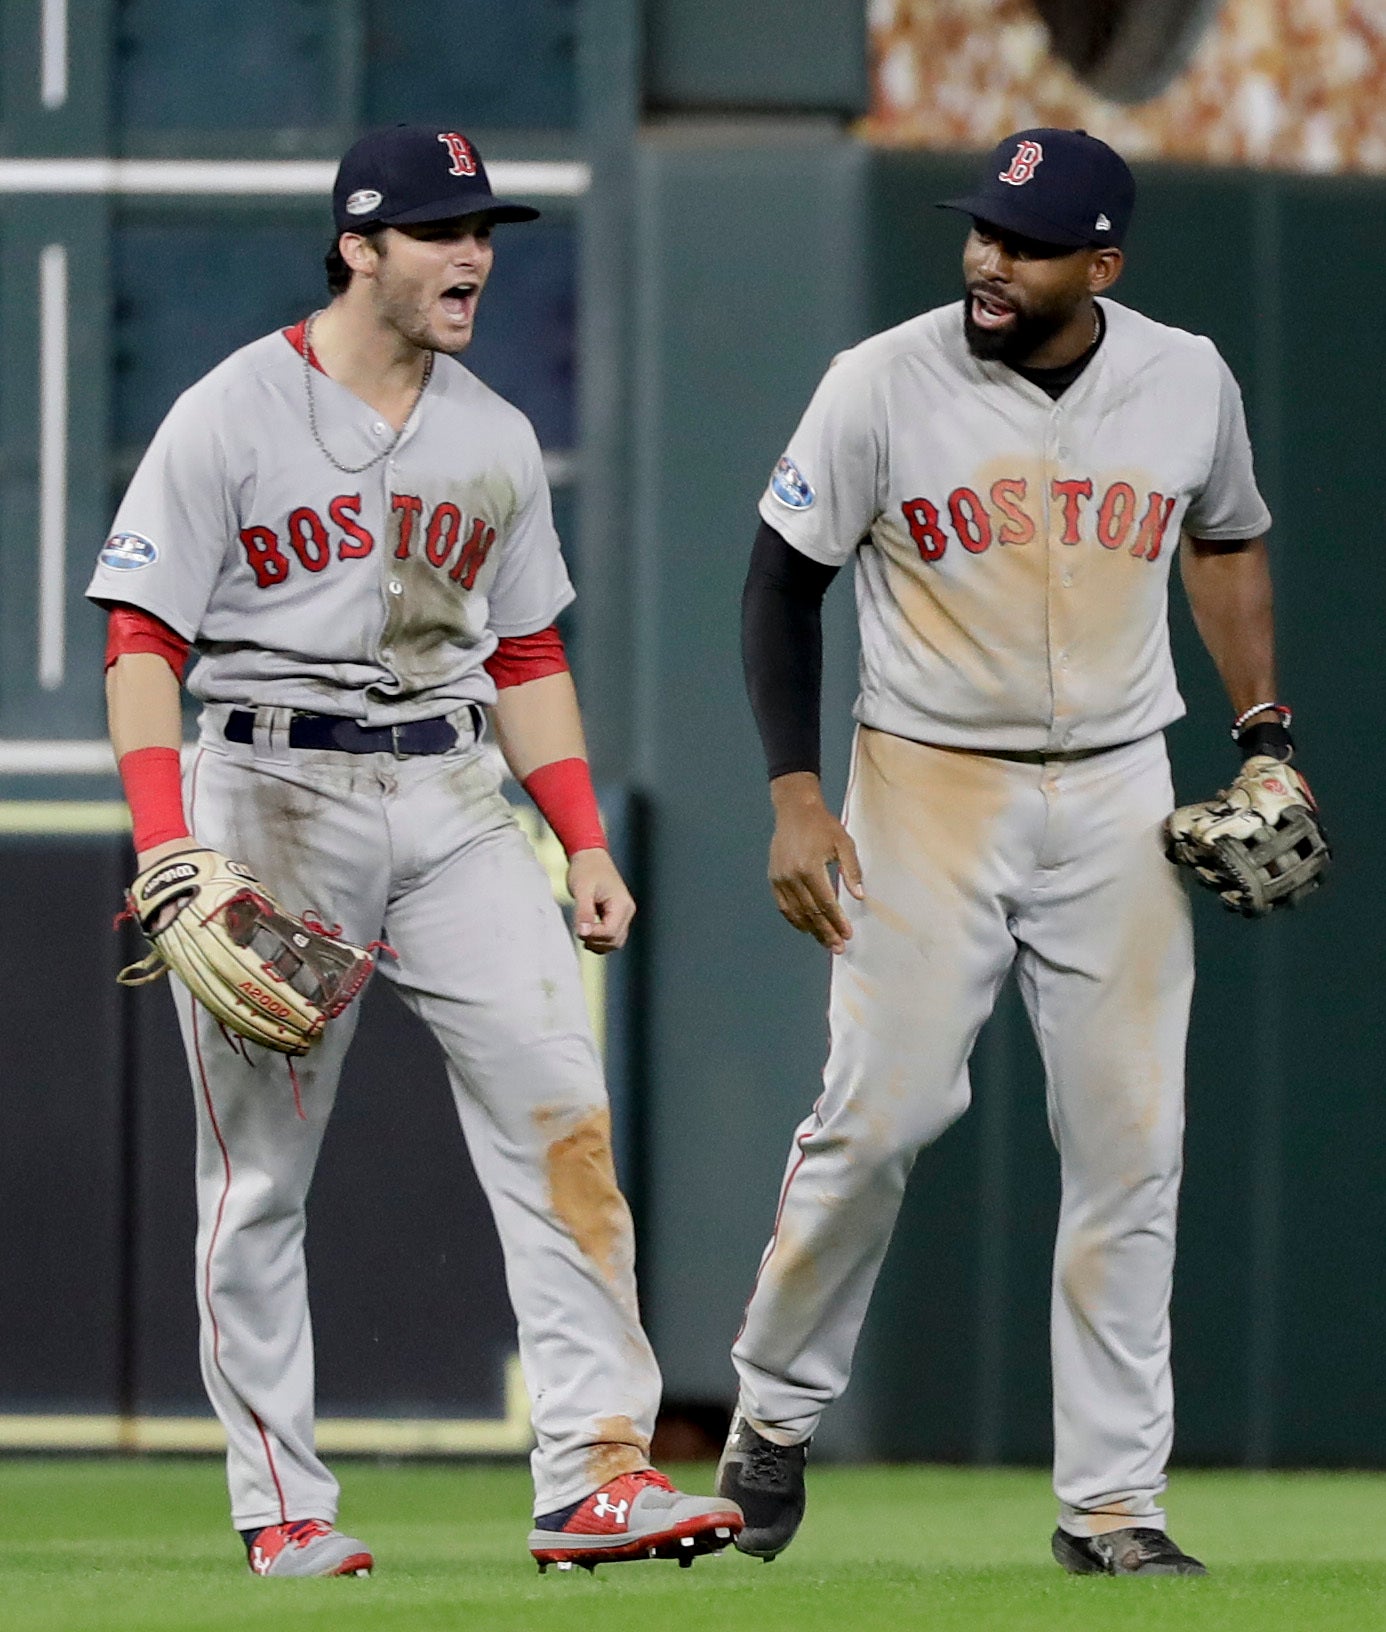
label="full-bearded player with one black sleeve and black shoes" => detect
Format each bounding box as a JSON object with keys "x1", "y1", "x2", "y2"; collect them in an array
[{"x1": 718, "y1": 129, "x2": 1327, "y2": 1575}]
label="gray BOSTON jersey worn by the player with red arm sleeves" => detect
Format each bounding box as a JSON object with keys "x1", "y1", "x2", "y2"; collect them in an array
[{"x1": 87, "y1": 333, "x2": 573, "y2": 725}]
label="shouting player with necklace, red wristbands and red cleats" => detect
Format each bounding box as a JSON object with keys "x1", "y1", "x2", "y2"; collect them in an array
[{"x1": 88, "y1": 126, "x2": 741, "y2": 1577}]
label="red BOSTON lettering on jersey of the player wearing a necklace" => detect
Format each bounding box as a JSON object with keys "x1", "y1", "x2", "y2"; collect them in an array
[{"x1": 240, "y1": 493, "x2": 496, "y2": 589}]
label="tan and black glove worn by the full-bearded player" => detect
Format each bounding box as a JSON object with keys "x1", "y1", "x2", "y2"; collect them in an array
[{"x1": 1164, "y1": 754, "x2": 1332, "y2": 917}]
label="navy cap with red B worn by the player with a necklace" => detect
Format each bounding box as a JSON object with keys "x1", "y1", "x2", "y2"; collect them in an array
[{"x1": 331, "y1": 124, "x2": 539, "y2": 232}]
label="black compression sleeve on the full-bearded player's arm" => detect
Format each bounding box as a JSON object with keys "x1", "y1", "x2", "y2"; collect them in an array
[{"x1": 741, "y1": 522, "x2": 839, "y2": 778}]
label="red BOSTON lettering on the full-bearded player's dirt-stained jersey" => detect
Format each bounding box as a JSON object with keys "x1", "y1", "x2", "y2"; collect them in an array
[{"x1": 900, "y1": 477, "x2": 1174, "y2": 561}]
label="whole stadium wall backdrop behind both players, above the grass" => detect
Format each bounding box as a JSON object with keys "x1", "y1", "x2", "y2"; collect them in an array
[{"x1": 0, "y1": 0, "x2": 1386, "y2": 1467}]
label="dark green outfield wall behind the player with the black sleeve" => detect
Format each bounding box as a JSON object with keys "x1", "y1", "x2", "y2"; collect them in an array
[{"x1": 632, "y1": 134, "x2": 1386, "y2": 1464}]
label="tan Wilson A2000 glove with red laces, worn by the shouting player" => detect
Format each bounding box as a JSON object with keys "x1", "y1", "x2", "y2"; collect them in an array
[{"x1": 118, "y1": 850, "x2": 375, "y2": 1054}]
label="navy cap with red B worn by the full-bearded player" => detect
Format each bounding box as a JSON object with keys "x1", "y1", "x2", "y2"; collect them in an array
[{"x1": 939, "y1": 126, "x2": 1136, "y2": 250}]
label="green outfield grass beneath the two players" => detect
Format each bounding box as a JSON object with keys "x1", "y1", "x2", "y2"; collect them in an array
[{"x1": 0, "y1": 1459, "x2": 1386, "y2": 1632}]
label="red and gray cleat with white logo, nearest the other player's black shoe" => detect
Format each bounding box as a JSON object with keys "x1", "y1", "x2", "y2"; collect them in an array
[{"x1": 529, "y1": 1467, "x2": 741, "y2": 1575}]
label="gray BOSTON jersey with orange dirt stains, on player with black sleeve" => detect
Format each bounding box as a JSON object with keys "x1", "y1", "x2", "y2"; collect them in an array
[{"x1": 761, "y1": 300, "x2": 1270, "y2": 749}]
